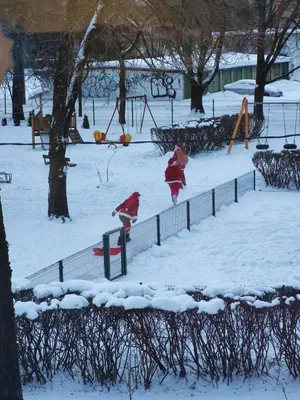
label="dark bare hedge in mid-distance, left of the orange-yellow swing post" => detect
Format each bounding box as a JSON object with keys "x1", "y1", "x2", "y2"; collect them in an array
[{"x1": 151, "y1": 114, "x2": 263, "y2": 155}]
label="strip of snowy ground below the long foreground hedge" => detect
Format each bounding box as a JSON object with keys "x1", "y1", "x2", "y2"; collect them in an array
[{"x1": 24, "y1": 372, "x2": 299, "y2": 400}]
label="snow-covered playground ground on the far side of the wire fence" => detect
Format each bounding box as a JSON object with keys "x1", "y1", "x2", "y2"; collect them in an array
[{"x1": 0, "y1": 81, "x2": 300, "y2": 278}]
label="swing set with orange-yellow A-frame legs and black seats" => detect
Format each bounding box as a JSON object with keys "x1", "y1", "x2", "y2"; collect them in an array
[{"x1": 227, "y1": 98, "x2": 300, "y2": 154}]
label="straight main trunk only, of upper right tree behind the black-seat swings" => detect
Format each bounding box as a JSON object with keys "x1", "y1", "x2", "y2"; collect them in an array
[{"x1": 254, "y1": 2, "x2": 266, "y2": 120}]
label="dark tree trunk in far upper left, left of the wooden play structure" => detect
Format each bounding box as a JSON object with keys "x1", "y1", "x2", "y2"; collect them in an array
[{"x1": 12, "y1": 34, "x2": 25, "y2": 121}]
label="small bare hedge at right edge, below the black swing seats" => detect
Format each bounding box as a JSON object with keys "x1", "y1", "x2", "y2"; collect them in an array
[{"x1": 252, "y1": 150, "x2": 300, "y2": 190}]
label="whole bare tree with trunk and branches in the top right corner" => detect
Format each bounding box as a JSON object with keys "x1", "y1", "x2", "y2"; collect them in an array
[{"x1": 251, "y1": 0, "x2": 300, "y2": 119}]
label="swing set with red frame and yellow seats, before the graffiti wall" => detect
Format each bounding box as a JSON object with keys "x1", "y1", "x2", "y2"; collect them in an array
[{"x1": 93, "y1": 95, "x2": 157, "y2": 148}]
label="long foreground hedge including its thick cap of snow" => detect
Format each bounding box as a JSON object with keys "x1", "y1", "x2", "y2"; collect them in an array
[{"x1": 15, "y1": 281, "x2": 300, "y2": 389}]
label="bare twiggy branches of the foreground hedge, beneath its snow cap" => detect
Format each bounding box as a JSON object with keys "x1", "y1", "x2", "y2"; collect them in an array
[{"x1": 16, "y1": 290, "x2": 300, "y2": 389}]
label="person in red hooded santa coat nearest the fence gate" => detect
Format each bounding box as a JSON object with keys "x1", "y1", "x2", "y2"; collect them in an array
[{"x1": 111, "y1": 192, "x2": 140, "y2": 246}]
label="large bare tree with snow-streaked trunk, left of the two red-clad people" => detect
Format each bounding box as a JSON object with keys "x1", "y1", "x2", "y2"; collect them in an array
[{"x1": 48, "y1": 0, "x2": 102, "y2": 221}]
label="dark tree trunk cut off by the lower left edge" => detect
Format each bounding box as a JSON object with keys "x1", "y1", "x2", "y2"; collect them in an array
[{"x1": 0, "y1": 199, "x2": 23, "y2": 400}]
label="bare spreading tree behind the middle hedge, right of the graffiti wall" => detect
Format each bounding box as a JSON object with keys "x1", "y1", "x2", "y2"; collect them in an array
[{"x1": 144, "y1": 0, "x2": 246, "y2": 113}]
